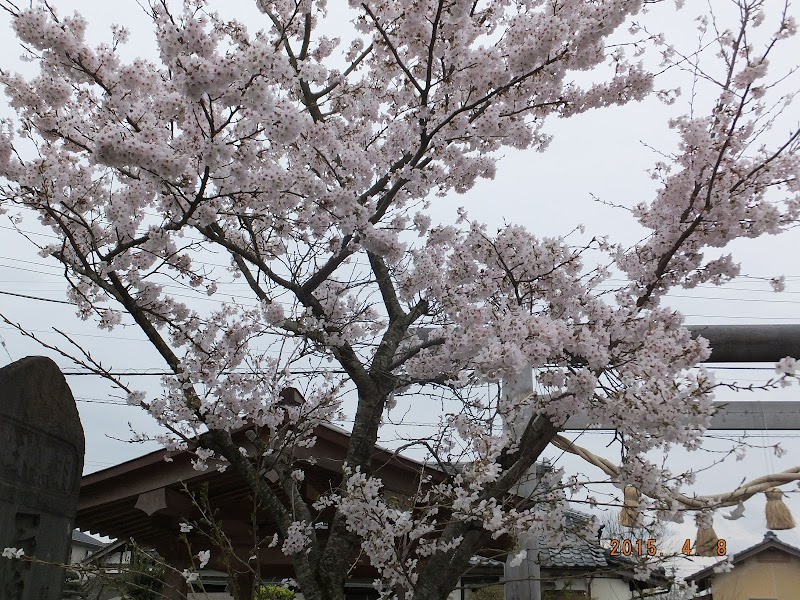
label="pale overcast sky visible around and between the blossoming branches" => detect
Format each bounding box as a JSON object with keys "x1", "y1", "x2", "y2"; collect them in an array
[{"x1": 0, "y1": 0, "x2": 800, "y2": 568}]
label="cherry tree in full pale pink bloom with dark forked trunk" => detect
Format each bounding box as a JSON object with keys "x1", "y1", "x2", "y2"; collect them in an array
[{"x1": 0, "y1": 0, "x2": 800, "y2": 600}]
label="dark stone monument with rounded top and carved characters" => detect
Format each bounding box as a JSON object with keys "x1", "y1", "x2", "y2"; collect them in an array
[{"x1": 0, "y1": 356, "x2": 84, "y2": 600}]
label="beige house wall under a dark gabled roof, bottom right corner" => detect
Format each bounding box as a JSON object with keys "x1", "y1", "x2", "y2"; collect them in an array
[{"x1": 711, "y1": 550, "x2": 800, "y2": 600}]
